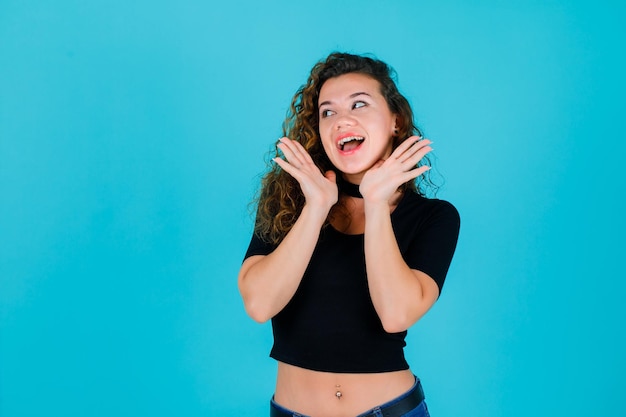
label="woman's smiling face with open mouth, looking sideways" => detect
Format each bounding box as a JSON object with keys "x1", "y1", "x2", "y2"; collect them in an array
[{"x1": 318, "y1": 73, "x2": 396, "y2": 183}]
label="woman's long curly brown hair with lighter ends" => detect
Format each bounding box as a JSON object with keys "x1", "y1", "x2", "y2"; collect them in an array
[{"x1": 255, "y1": 52, "x2": 438, "y2": 244}]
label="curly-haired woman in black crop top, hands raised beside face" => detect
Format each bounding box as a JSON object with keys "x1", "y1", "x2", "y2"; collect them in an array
[{"x1": 238, "y1": 53, "x2": 459, "y2": 417}]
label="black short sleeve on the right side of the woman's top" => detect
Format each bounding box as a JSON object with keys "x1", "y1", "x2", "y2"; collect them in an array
[{"x1": 404, "y1": 200, "x2": 461, "y2": 294}]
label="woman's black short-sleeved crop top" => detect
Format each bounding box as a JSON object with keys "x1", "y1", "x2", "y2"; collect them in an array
[{"x1": 245, "y1": 192, "x2": 460, "y2": 373}]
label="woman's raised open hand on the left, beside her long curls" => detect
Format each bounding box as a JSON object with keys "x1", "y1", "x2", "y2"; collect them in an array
[{"x1": 273, "y1": 137, "x2": 339, "y2": 217}]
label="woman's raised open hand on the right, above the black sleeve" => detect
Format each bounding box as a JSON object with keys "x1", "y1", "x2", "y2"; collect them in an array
[{"x1": 359, "y1": 136, "x2": 432, "y2": 203}]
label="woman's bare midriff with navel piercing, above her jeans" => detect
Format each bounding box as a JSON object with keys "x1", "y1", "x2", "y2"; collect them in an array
[{"x1": 274, "y1": 362, "x2": 415, "y2": 417}]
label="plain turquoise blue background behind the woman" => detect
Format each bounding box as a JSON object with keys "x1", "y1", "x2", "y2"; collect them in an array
[{"x1": 0, "y1": 0, "x2": 626, "y2": 417}]
